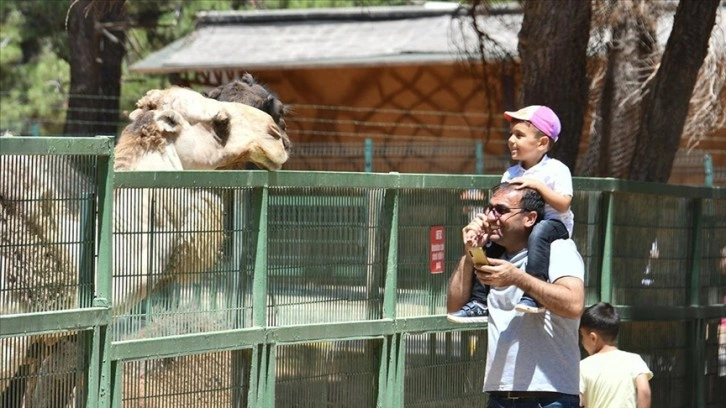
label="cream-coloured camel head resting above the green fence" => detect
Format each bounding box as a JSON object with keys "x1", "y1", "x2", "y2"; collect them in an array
[{"x1": 125, "y1": 87, "x2": 288, "y2": 170}]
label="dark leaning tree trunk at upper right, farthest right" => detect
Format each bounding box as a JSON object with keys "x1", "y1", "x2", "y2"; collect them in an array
[{"x1": 629, "y1": 0, "x2": 720, "y2": 183}]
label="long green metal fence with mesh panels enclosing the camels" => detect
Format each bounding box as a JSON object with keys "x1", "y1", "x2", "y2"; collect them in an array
[{"x1": 0, "y1": 138, "x2": 726, "y2": 407}]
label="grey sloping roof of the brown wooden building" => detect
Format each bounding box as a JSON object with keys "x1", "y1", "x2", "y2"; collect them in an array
[{"x1": 131, "y1": 2, "x2": 522, "y2": 73}]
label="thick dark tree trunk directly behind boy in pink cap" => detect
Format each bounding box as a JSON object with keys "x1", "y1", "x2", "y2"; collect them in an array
[{"x1": 518, "y1": 0, "x2": 591, "y2": 170}]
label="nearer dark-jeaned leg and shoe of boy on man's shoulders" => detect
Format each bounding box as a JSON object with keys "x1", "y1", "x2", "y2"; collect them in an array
[{"x1": 515, "y1": 220, "x2": 570, "y2": 313}]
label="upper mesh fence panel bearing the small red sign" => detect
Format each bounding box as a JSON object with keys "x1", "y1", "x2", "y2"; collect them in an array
[{"x1": 396, "y1": 189, "x2": 474, "y2": 317}]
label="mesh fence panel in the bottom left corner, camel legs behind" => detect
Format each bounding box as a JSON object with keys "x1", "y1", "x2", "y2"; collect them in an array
[{"x1": 0, "y1": 332, "x2": 88, "y2": 407}]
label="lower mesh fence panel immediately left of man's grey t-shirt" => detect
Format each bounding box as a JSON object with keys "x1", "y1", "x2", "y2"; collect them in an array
[{"x1": 404, "y1": 330, "x2": 487, "y2": 408}]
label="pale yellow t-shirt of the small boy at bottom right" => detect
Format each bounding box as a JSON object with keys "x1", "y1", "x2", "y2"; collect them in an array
[{"x1": 580, "y1": 350, "x2": 653, "y2": 408}]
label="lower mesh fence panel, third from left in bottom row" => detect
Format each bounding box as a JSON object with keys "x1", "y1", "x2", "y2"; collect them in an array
[{"x1": 275, "y1": 339, "x2": 381, "y2": 408}]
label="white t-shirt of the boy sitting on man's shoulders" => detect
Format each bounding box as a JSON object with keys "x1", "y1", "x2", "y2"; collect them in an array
[{"x1": 502, "y1": 155, "x2": 575, "y2": 236}]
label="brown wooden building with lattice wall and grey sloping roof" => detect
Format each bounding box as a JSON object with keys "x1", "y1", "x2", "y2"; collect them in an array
[{"x1": 131, "y1": 2, "x2": 726, "y2": 184}]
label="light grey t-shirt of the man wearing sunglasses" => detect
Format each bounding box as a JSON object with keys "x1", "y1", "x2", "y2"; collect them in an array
[{"x1": 484, "y1": 239, "x2": 585, "y2": 395}]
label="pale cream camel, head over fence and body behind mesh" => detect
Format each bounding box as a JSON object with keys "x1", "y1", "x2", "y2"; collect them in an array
[{"x1": 0, "y1": 88, "x2": 288, "y2": 405}]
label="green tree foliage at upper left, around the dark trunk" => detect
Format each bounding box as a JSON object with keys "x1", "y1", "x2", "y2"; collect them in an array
[{"x1": 0, "y1": 0, "x2": 446, "y2": 135}]
